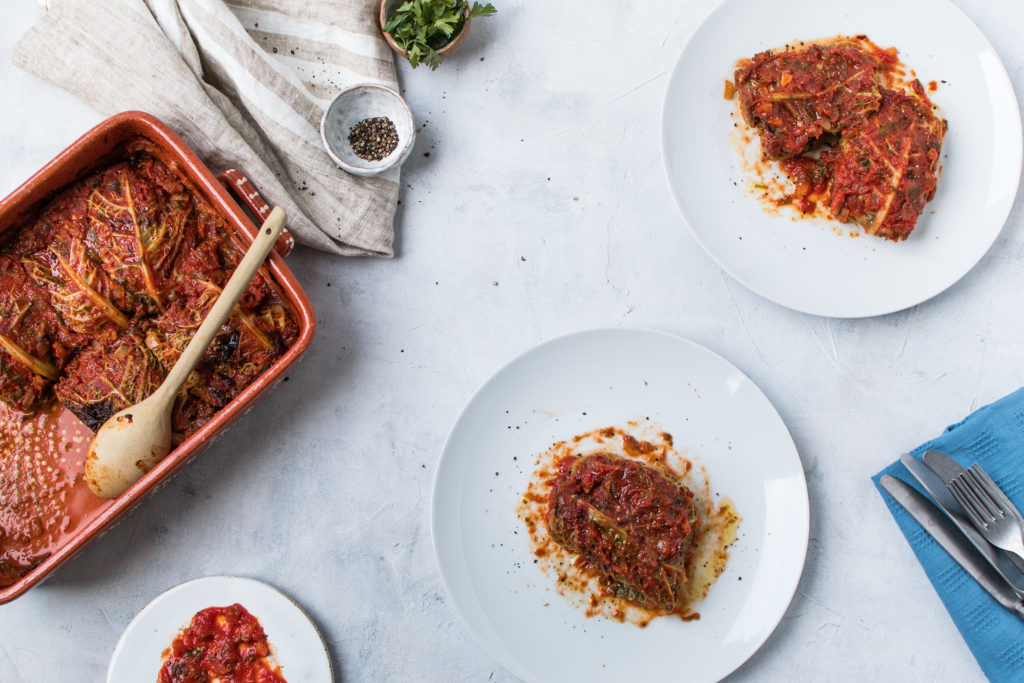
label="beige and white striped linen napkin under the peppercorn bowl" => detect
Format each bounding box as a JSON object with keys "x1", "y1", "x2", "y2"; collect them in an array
[{"x1": 13, "y1": 0, "x2": 398, "y2": 256}]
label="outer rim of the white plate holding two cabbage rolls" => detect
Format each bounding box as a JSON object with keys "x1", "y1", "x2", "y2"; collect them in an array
[{"x1": 660, "y1": 0, "x2": 1024, "y2": 318}]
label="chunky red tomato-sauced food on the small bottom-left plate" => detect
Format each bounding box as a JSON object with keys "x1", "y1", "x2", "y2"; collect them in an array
[{"x1": 157, "y1": 603, "x2": 286, "y2": 683}]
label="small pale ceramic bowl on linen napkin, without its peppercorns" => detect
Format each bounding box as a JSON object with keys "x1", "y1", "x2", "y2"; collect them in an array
[{"x1": 321, "y1": 83, "x2": 416, "y2": 175}]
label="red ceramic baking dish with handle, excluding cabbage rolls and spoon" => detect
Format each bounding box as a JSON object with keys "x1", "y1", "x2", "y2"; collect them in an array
[{"x1": 0, "y1": 112, "x2": 315, "y2": 604}]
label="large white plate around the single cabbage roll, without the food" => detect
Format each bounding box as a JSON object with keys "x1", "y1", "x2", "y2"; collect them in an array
[{"x1": 432, "y1": 330, "x2": 808, "y2": 681}]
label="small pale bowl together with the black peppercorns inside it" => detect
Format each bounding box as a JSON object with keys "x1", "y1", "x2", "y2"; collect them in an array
[{"x1": 321, "y1": 83, "x2": 416, "y2": 175}]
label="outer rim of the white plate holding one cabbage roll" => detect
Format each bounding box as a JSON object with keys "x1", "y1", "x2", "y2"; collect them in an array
[{"x1": 430, "y1": 327, "x2": 810, "y2": 678}]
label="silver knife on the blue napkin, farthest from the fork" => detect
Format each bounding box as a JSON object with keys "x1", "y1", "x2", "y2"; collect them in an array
[{"x1": 880, "y1": 474, "x2": 1024, "y2": 621}]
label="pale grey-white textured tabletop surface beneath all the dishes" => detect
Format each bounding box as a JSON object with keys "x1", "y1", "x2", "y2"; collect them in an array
[{"x1": 0, "y1": 0, "x2": 1024, "y2": 683}]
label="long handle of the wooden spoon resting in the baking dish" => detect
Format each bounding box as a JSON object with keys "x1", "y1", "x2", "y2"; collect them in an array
[{"x1": 157, "y1": 207, "x2": 285, "y2": 401}]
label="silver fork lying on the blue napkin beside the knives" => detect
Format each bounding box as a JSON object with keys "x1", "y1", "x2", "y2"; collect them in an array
[{"x1": 946, "y1": 464, "x2": 1024, "y2": 558}]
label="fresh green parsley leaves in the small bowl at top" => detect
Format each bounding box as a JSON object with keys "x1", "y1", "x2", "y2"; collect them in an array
[{"x1": 384, "y1": 0, "x2": 498, "y2": 69}]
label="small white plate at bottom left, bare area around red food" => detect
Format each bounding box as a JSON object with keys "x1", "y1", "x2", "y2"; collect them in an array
[{"x1": 106, "y1": 577, "x2": 334, "y2": 683}]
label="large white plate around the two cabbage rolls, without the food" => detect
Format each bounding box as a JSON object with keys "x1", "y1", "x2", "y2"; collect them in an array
[{"x1": 662, "y1": 0, "x2": 1021, "y2": 317}]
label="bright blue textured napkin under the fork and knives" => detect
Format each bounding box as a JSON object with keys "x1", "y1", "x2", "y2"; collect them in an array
[{"x1": 871, "y1": 388, "x2": 1024, "y2": 682}]
